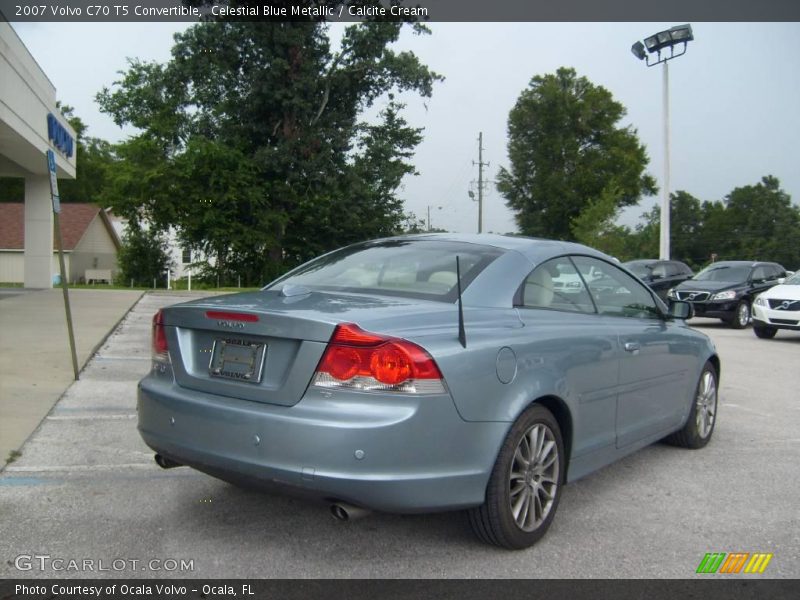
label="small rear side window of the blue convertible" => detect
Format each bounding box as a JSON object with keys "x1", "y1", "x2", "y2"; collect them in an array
[{"x1": 521, "y1": 256, "x2": 595, "y2": 313}]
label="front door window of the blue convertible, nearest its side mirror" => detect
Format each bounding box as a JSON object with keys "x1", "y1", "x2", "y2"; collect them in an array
[{"x1": 574, "y1": 256, "x2": 661, "y2": 319}]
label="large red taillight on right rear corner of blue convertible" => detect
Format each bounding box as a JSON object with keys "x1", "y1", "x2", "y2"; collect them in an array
[{"x1": 312, "y1": 323, "x2": 445, "y2": 394}]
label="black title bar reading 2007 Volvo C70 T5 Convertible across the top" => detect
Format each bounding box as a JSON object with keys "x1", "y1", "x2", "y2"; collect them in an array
[{"x1": 0, "y1": 0, "x2": 800, "y2": 22}]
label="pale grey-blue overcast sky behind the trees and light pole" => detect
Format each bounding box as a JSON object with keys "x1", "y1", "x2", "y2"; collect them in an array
[{"x1": 13, "y1": 22, "x2": 800, "y2": 233}]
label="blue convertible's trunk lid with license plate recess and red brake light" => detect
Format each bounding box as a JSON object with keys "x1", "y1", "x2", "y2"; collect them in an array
[{"x1": 162, "y1": 291, "x2": 455, "y2": 406}]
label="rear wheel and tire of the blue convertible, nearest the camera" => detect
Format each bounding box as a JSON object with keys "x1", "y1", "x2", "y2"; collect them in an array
[{"x1": 468, "y1": 404, "x2": 566, "y2": 550}]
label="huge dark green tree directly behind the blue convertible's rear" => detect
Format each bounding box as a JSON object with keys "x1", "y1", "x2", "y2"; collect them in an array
[{"x1": 98, "y1": 14, "x2": 441, "y2": 282}]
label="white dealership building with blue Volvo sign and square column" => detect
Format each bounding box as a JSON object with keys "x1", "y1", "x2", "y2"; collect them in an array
[{"x1": 0, "y1": 20, "x2": 77, "y2": 288}]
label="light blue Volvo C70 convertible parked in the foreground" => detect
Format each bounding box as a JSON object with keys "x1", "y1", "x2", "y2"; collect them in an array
[{"x1": 138, "y1": 234, "x2": 720, "y2": 548}]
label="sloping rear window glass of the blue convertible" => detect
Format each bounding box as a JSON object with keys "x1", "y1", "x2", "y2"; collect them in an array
[{"x1": 264, "y1": 240, "x2": 503, "y2": 302}]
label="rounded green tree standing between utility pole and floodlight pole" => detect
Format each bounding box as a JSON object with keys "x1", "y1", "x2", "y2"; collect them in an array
[{"x1": 497, "y1": 67, "x2": 656, "y2": 240}]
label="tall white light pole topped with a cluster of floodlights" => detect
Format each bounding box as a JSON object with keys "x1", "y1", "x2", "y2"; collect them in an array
[{"x1": 631, "y1": 23, "x2": 694, "y2": 260}]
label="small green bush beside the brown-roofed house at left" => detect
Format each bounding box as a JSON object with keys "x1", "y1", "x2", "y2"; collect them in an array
[{"x1": 118, "y1": 224, "x2": 173, "y2": 287}]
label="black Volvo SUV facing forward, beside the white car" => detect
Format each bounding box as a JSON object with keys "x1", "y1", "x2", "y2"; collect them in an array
[{"x1": 668, "y1": 260, "x2": 786, "y2": 329}]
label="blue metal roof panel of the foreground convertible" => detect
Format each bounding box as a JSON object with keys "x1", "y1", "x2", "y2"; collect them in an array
[{"x1": 384, "y1": 233, "x2": 614, "y2": 263}]
